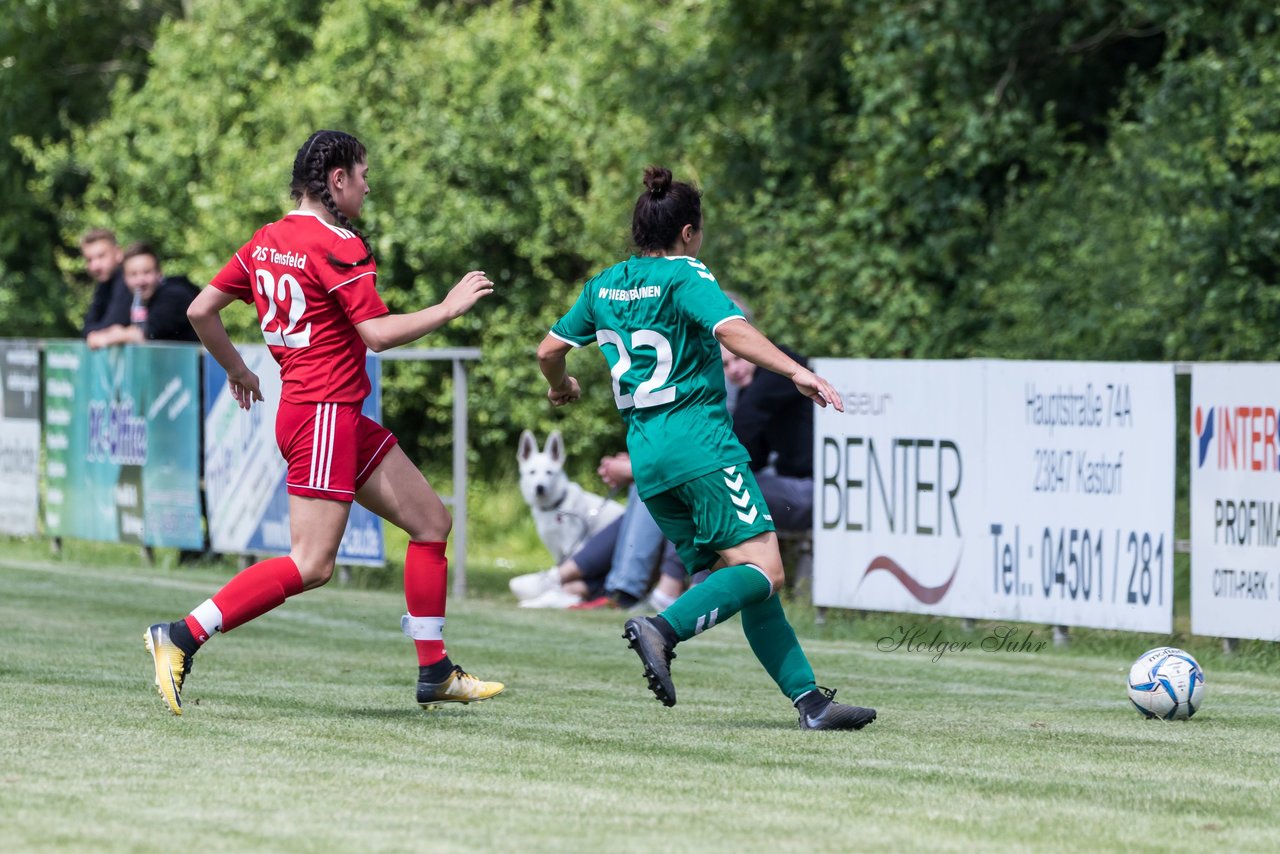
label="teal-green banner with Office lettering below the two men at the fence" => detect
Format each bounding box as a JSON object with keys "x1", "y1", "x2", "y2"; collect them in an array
[{"x1": 45, "y1": 341, "x2": 204, "y2": 549}]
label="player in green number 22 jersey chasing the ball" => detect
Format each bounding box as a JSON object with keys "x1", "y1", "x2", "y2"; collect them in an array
[{"x1": 538, "y1": 166, "x2": 876, "y2": 730}]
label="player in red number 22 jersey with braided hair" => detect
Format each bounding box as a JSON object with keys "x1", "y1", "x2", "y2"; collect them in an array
[{"x1": 146, "y1": 131, "x2": 504, "y2": 714}]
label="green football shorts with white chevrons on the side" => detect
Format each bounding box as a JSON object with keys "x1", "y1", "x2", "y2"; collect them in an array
[{"x1": 644, "y1": 462, "x2": 773, "y2": 575}]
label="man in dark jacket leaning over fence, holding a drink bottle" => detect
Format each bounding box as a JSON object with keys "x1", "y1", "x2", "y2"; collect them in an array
[{"x1": 87, "y1": 243, "x2": 200, "y2": 350}]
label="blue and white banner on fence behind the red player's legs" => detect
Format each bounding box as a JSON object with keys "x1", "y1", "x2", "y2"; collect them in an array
[{"x1": 205, "y1": 344, "x2": 385, "y2": 566}]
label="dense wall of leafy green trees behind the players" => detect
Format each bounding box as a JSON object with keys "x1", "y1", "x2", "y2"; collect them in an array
[{"x1": 17, "y1": 0, "x2": 1280, "y2": 467}]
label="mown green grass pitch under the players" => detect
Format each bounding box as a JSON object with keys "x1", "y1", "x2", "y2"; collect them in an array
[{"x1": 0, "y1": 547, "x2": 1280, "y2": 853}]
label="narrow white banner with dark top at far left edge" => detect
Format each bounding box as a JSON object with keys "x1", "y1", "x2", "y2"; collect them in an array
[{"x1": 0, "y1": 341, "x2": 40, "y2": 536}]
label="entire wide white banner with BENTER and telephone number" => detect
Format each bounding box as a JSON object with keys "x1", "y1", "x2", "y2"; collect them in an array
[{"x1": 814, "y1": 360, "x2": 1175, "y2": 631}]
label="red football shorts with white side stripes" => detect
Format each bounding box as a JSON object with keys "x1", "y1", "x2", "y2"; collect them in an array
[{"x1": 275, "y1": 401, "x2": 396, "y2": 502}]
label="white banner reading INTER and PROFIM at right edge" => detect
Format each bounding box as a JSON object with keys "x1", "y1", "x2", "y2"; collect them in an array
[{"x1": 1190, "y1": 364, "x2": 1280, "y2": 640}]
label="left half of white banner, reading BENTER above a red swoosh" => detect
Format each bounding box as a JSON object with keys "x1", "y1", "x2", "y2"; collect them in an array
[{"x1": 813, "y1": 359, "x2": 989, "y2": 616}]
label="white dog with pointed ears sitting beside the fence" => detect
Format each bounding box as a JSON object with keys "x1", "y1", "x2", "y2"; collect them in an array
[{"x1": 509, "y1": 430, "x2": 623, "y2": 607}]
